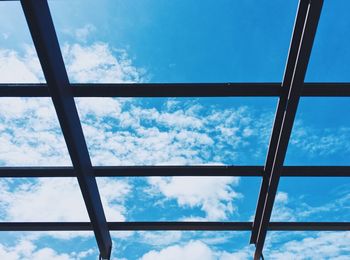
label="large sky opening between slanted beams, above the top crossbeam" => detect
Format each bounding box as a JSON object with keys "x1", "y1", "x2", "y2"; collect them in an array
[{"x1": 50, "y1": 0, "x2": 298, "y2": 82}]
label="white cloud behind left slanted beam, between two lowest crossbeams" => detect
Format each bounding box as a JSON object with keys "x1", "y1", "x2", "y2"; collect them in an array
[{"x1": 0, "y1": 178, "x2": 130, "y2": 222}]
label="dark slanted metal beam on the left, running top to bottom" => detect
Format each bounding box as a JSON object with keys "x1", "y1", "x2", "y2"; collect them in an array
[{"x1": 21, "y1": 0, "x2": 112, "y2": 259}]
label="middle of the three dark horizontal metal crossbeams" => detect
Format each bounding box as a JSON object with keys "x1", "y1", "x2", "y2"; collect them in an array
[{"x1": 0, "y1": 166, "x2": 350, "y2": 178}]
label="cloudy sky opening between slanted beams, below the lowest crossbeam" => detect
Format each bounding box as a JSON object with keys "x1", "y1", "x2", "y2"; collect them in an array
[{"x1": 111, "y1": 231, "x2": 254, "y2": 260}]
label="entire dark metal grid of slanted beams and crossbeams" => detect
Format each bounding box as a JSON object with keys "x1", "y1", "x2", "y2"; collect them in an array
[{"x1": 0, "y1": 0, "x2": 350, "y2": 260}]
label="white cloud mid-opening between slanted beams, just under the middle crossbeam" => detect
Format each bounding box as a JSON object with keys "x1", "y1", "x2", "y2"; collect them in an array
[{"x1": 149, "y1": 177, "x2": 242, "y2": 220}]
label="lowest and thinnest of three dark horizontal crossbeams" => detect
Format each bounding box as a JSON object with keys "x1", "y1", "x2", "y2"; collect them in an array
[{"x1": 0, "y1": 222, "x2": 350, "y2": 231}]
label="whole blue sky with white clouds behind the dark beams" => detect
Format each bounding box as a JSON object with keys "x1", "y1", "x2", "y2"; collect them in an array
[{"x1": 0, "y1": 0, "x2": 350, "y2": 260}]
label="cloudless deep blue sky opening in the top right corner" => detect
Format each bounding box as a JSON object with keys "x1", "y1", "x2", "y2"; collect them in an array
[{"x1": 306, "y1": 0, "x2": 350, "y2": 82}]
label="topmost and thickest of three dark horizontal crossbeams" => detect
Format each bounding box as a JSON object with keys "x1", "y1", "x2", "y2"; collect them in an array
[{"x1": 0, "y1": 83, "x2": 350, "y2": 97}]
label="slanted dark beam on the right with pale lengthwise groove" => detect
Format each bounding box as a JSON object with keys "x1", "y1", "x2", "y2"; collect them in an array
[{"x1": 251, "y1": 0, "x2": 323, "y2": 260}]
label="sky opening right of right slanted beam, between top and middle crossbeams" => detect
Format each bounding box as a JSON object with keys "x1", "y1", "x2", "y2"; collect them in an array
[{"x1": 285, "y1": 98, "x2": 350, "y2": 165}]
